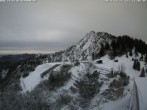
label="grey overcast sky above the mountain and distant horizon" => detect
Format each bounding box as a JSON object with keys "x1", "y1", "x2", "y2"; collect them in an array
[{"x1": 0, "y1": 0, "x2": 147, "y2": 54}]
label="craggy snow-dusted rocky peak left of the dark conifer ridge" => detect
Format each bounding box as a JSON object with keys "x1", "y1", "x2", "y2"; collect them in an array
[{"x1": 49, "y1": 31, "x2": 115, "y2": 61}]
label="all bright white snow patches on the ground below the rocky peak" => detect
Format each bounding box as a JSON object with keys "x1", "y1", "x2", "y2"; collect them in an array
[{"x1": 21, "y1": 55, "x2": 147, "y2": 110}]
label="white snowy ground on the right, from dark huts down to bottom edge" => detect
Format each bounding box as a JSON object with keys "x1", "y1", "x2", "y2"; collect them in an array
[{"x1": 93, "y1": 55, "x2": 147, "y2": 110}]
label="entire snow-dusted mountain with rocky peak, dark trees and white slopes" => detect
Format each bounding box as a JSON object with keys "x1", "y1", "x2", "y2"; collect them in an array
[{"x1": 0, "y1": 31, "x2": 147, "y2": 110}]
